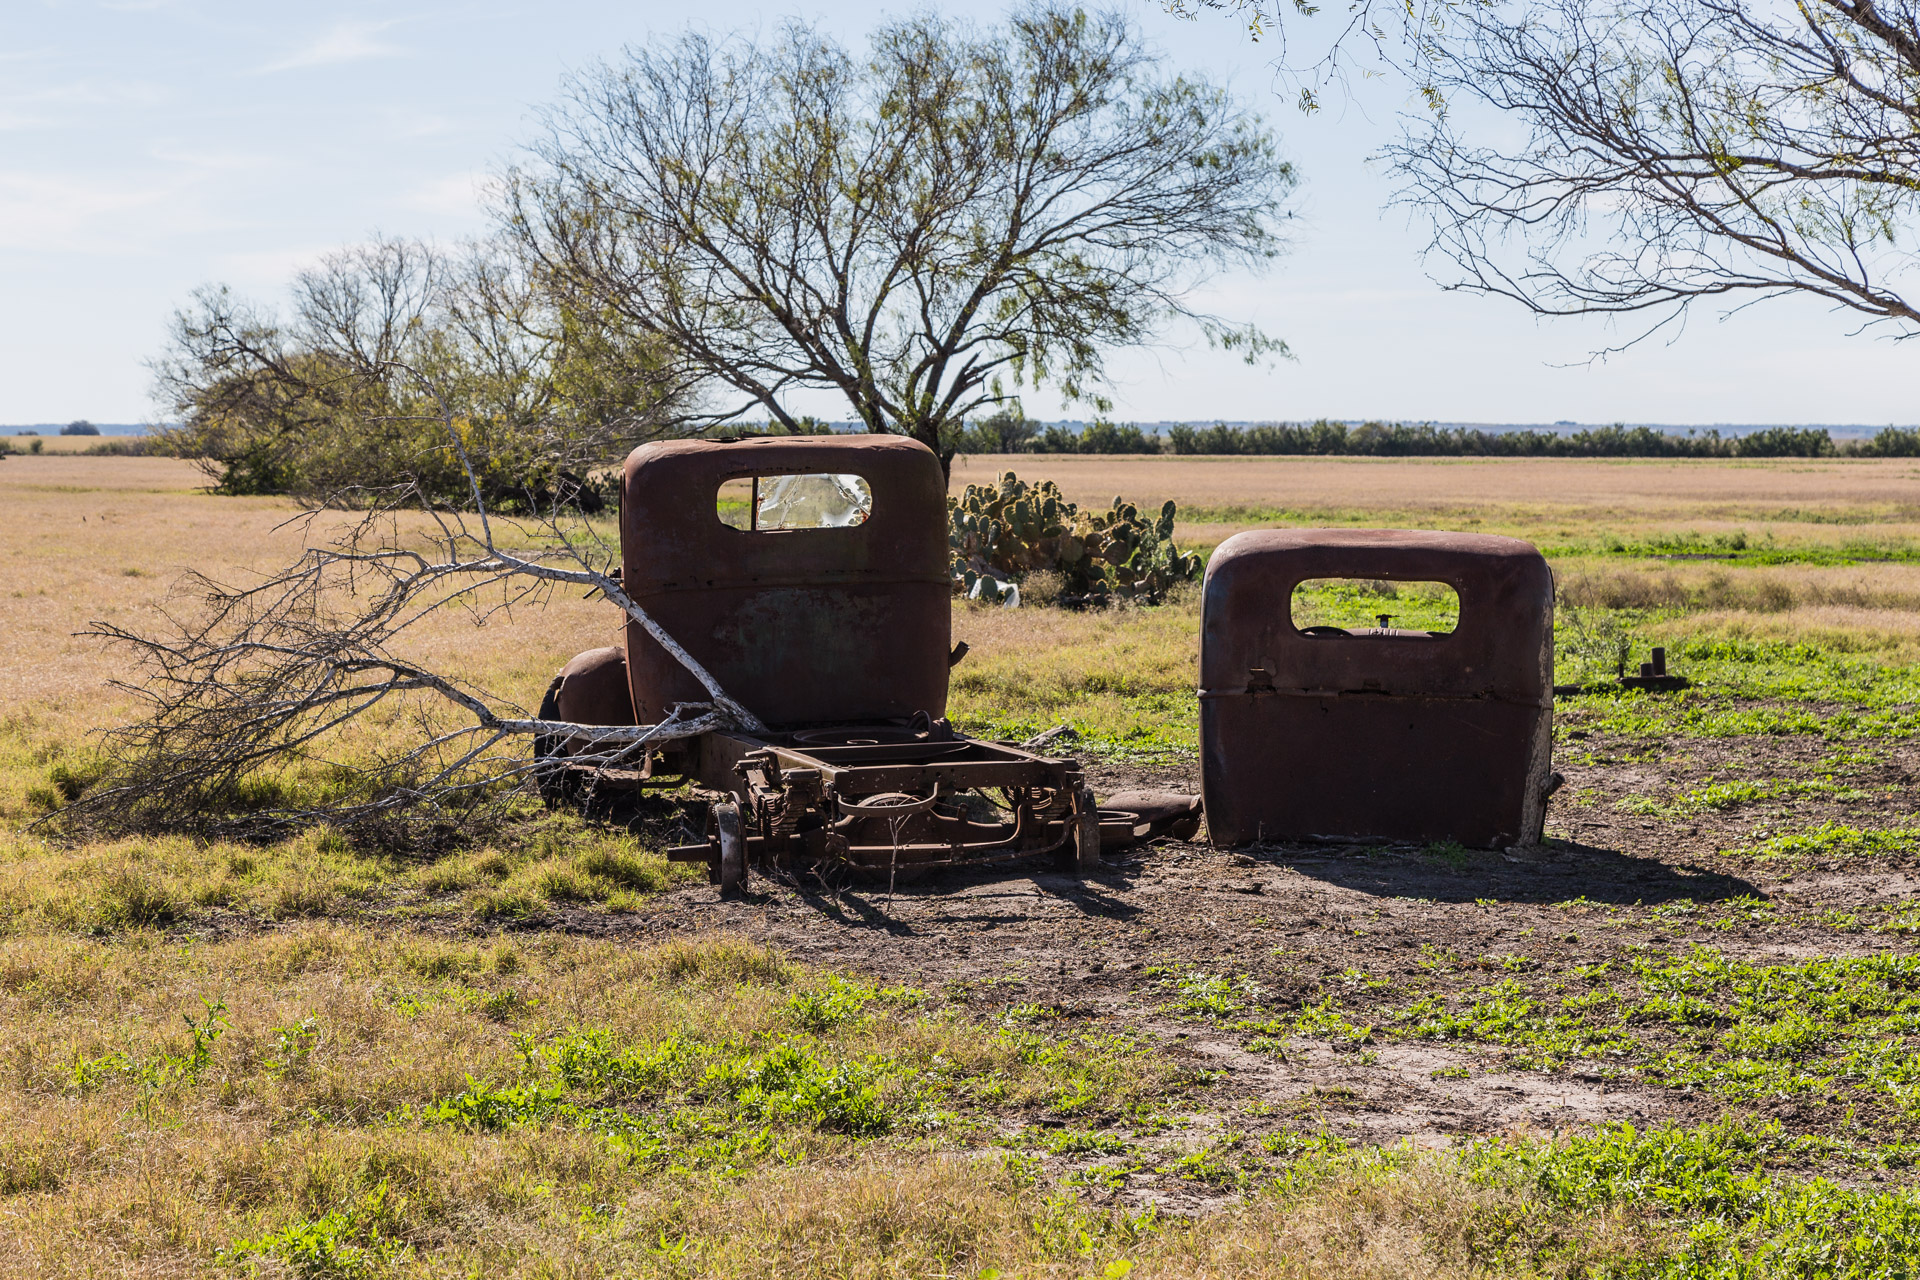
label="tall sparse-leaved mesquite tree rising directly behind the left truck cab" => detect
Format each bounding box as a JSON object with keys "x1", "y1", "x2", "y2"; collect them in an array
[{"x1": 503, "y1": 6, "x2": 1294, "y2": 474}]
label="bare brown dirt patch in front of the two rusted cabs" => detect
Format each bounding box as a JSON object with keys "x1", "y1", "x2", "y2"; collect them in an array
[{"x1": 518, "y1": 737, "x2": 1920, "y2": 1207}]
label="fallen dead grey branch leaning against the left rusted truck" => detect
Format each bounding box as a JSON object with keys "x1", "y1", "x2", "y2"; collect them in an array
[{"x1": 42, "y1": 362, "x2": 764, "y2": 837}]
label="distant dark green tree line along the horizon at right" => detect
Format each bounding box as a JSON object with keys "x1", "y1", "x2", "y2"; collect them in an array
[{"x1": 956, "y1": 413, "x2": 1920, "y2": 459}]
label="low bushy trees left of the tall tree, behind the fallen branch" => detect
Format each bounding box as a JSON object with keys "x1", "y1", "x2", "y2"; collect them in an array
[{"x1": 154, "y1": 238, "x2": 687, "y2": 510}]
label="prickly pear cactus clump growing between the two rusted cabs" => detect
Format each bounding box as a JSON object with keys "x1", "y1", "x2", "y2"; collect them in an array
[{"x1": 947, "y1": 472, "x2": 1200, "y2": 604}]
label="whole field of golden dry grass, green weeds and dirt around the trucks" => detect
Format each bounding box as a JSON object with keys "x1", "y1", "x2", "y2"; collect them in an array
[{"x1": 11, "y1": 450, "x2": 1920, "y2": 1280}]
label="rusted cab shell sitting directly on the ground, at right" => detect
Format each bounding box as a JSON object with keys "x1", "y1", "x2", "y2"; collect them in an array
[{"x1": 1200, "y1": 530, "x2": 1553, "y2": 848}]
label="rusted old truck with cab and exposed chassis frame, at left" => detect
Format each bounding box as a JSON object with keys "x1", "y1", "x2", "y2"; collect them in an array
[{"x1": 551, "y1": 436, "x2": 1102, "y2": 889}]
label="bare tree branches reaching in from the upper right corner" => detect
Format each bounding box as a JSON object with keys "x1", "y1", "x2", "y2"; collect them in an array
[{"x1": 1392, "y1": 0, "x2": 1920, "y2": 340}]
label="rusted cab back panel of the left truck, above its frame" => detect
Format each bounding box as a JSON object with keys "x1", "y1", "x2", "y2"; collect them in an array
[{"x1": 620, "y1": 436, "x2": 952, "y2": 729}]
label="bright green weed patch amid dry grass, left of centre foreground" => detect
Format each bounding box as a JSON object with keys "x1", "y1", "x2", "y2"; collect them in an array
[{"x1": 392, "y1": 975, "x2": 1171, "y2": 1171}]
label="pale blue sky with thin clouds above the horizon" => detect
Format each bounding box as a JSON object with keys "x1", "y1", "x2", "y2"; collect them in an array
[{"x1": 0, "y1": 0, "x2": 1920, "y2": 424}]
